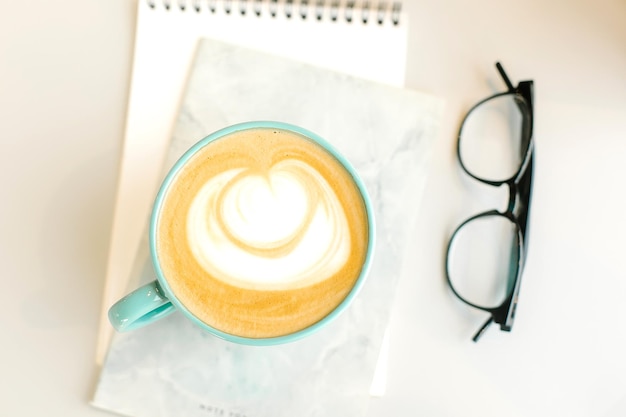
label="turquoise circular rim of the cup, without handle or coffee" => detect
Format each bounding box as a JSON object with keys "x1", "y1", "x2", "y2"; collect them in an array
[{"x1": 149, "y1": 121, "x2": 376, "y2": 346}]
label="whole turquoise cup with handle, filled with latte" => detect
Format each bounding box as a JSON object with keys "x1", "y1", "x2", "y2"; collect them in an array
[{"x1": 109, "y1": 121, "x2": 375, "y2": 345}]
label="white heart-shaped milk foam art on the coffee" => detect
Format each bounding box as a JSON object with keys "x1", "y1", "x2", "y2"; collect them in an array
[{"x1": 186, "y1": 159, "x2": 351, "y2": 289}]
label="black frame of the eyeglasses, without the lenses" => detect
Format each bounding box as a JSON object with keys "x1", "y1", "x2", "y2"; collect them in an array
[{"x1": 445, "y1": 62, "x2": 534, "y2": 342}]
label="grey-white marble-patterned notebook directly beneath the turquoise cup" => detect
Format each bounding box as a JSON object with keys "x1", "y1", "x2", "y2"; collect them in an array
[{"x1": 92, "y1": 39, "x2": 442, "y2": 417}]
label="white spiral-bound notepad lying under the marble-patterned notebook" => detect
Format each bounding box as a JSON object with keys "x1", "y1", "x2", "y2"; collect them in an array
[{"x1": 96, "y1": 0, "x2": 408, "y2": 364}]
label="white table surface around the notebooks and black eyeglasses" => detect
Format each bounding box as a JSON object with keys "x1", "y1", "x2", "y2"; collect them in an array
[{"x1": 0, "y1": 0, "x2": 626, "y2": 417}]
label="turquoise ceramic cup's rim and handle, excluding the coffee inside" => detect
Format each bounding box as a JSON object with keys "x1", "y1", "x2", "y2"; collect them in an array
[{"x1": 109, "y1": 121, "x2": 375, "y2": 346}]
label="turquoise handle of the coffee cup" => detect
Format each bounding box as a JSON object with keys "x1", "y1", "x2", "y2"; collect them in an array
[{"x1": 109, "y1": 280, "x2": 175, "y2": 332}]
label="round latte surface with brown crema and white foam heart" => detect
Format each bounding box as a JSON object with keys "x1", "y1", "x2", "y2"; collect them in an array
[{"x1": 156, "y1": 128, "x2": 369, "y2": 338}]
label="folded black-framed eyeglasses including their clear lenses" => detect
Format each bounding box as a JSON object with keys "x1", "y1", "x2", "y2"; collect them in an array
[{"x1": 445, "y1": 63, "x2": 534, "y2": 342}]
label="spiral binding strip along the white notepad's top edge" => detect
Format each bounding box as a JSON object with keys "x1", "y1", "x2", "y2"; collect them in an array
[{"x1": 144, "y1": 0, "x2": 402, "y2": 25}]
